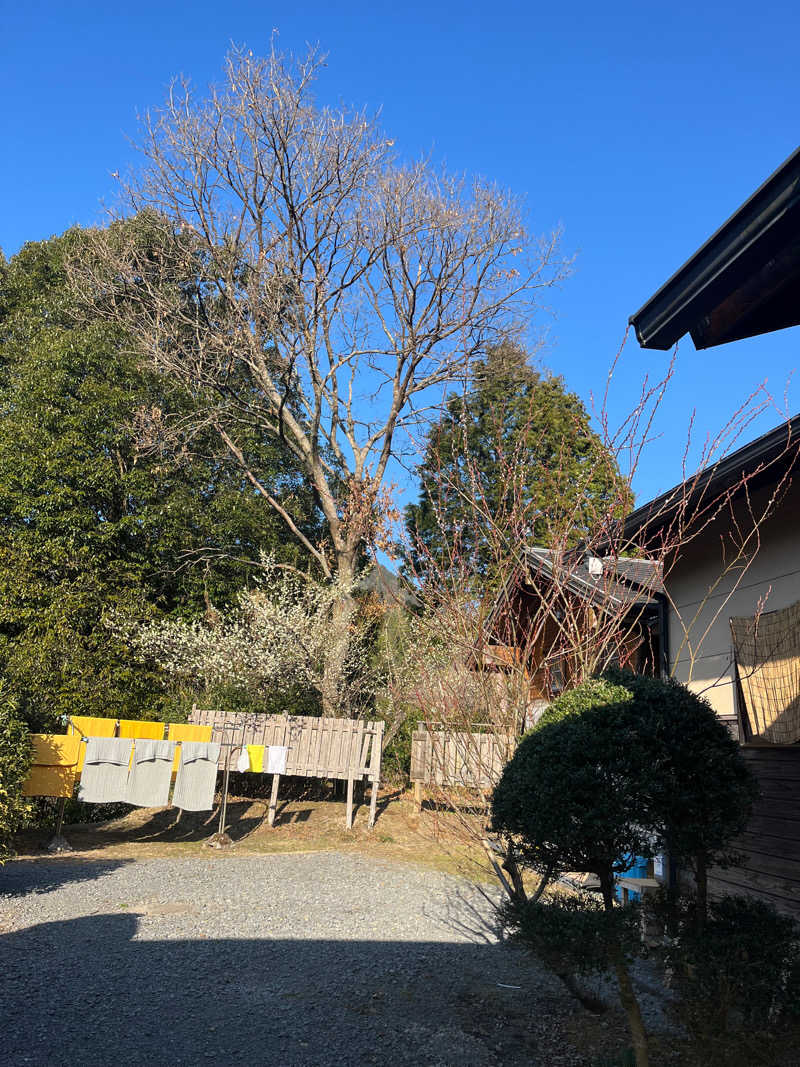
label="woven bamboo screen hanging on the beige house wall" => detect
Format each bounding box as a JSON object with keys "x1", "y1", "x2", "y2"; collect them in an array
[{"x1": 731, "y1": 601, "x2": 800, "y2": 745}]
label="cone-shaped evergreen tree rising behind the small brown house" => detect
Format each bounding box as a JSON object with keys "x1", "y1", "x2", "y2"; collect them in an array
[{"x1": 405, "y1": 344, "x2": 630, "y2": 574}]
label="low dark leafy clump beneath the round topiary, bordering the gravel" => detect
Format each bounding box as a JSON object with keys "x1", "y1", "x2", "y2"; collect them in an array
[{"x1": 499, "y1": 891, "x2": 639, "y2": 975}]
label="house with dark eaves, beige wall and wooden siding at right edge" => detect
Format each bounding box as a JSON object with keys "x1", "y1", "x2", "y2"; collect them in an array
[{"x1": 626, "y1": 149, "x2": 800, "y2": 917}]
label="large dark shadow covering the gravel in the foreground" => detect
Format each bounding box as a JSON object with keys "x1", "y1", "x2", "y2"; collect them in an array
[{"x1": 0, "y1": 914, "x2": 582, "y2": 1067}]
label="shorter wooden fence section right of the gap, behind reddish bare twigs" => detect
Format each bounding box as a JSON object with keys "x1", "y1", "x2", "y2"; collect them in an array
[{"x1": 411, "y1": 727, "x2": 516, "y2": 805}]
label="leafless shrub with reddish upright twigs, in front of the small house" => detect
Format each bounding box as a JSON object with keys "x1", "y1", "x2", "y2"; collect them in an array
[{"x1": 405, "y1": 343, "x2": 800, "y2": 857}]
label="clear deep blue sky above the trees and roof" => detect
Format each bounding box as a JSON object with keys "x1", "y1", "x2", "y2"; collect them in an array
[{"x1": 0, "y1": 0, "x2": 800, "y2": 503}]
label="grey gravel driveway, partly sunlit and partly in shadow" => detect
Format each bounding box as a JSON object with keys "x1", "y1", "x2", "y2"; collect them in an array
[{"x1": 0, "y1": 853, "x2": 585, "y2": 1067}]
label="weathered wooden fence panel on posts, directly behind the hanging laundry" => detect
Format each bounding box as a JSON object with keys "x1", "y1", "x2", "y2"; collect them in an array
[{"x1": 189, "y1": 707, "x2": 384, "y2": 829}]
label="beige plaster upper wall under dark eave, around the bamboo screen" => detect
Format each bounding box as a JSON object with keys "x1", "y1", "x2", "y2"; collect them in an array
[{"x1": 666, "y1": 479, "x2": 800, "y2": 718}]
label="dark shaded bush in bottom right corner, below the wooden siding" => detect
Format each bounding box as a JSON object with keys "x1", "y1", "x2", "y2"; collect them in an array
[{"x1": 667, "y1": 896, "x2": 800, "y2": 1047}]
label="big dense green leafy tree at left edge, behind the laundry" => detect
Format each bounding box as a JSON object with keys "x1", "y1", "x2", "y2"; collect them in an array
[{"x1": 0, "y1": 231, "x2": 315, "y2": 727}]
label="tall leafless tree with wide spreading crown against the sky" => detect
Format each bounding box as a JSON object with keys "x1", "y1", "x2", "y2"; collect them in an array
[{"x1": 73, "y1": 43, "x2": 564, "y2": 710}]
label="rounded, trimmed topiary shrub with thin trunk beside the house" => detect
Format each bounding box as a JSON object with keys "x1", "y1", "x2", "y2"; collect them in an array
[{"x1": 492, "y1": 671, "x2": 756, "y2": 1065}]
